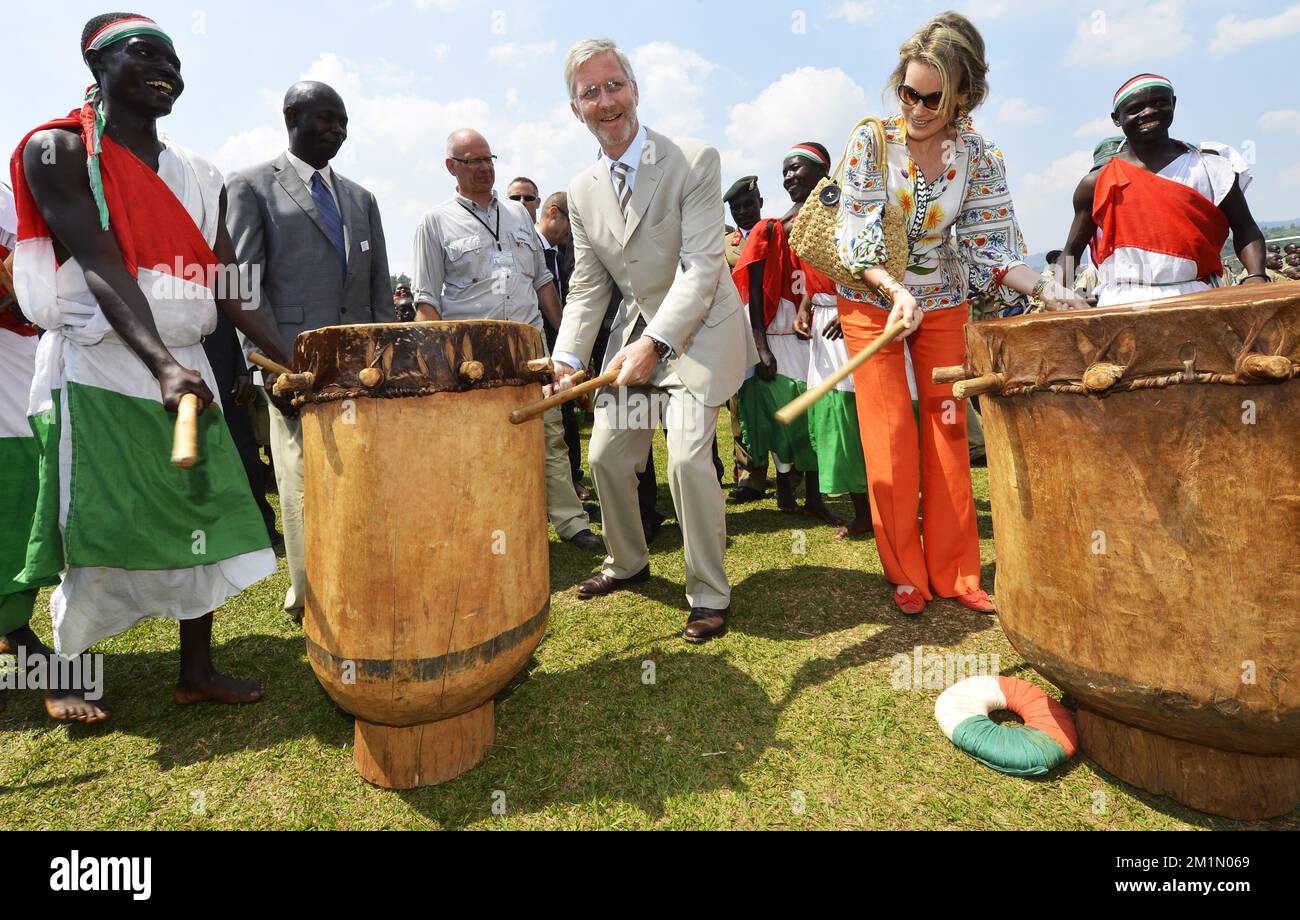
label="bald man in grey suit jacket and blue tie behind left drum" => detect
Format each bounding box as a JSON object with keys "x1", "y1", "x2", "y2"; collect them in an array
[{"x1": 226, "y1": 82, "x2": 395, "y2": 621}]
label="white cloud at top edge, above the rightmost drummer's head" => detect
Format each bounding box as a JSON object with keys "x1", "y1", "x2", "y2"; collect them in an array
[{"x1": 1066, "y1": 0, "x2": 1192, "y2": 69}]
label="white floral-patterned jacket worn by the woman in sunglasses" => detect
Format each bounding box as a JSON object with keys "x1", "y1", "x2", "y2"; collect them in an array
[{"x1": 835, "y1": 116, "x2": 1028, "y2": 316}]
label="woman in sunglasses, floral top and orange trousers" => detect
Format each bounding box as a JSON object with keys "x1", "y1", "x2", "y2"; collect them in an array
[{"x1": 836, "y1": 13, "x2": 1087, "y2": 613}]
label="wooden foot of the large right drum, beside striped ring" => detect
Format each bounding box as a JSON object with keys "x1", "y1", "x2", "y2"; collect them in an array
[{"x1": 1075, "y1": 706, "x2": 1300, "y2": 821}]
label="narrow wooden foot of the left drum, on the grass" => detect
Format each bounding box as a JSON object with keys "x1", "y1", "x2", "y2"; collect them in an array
[{"x1": 352, "y1": 700, "x2": 495, "y2": 789}]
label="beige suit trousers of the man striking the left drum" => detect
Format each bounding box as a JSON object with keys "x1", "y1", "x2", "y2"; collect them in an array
[{"x1": 589, "y1": 383, "x2": 731, "y2": 609}]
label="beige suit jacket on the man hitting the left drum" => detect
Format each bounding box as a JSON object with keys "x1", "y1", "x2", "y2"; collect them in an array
[{"x1": 554, "y1": 131, "x2": 758, "y2": 407}]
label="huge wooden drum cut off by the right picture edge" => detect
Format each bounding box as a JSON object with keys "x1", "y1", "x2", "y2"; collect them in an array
[{"x1": 957, "y1": 283, "x2": 1300, "y2": 819}]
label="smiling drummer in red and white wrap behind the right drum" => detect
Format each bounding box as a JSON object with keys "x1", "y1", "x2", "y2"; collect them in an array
[{"x1": 1061, "y1": 74, "x2": 1269, "y2": 307}]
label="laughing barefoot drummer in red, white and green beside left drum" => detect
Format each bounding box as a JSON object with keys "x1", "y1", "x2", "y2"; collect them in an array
[{"x1": 0, "y1": 13, "x2": 289, "y2": 721}]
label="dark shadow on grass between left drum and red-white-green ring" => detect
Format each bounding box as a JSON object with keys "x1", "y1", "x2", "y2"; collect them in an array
[{"x1": 400, "y1": 647, "x2": 780, "y2": 828}]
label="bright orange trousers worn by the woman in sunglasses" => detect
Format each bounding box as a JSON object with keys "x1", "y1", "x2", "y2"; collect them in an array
[{"x1": 840, "y1": 298, "x2": 980, "y2": 600}]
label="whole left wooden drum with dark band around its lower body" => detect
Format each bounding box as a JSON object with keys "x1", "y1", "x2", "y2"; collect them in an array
[{"x1": 294, "y1": 322, "x2": 550, "y2": 789}]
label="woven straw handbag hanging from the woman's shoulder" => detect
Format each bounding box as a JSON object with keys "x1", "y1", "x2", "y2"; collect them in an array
[{"x1": 790, "y1": 117, "x2": 909, "y2": 292}]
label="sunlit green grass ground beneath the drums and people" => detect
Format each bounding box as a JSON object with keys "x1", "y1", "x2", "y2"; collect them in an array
[{"x1": 0, "y1": 429, "x2": 1300, "y2": 830}]
